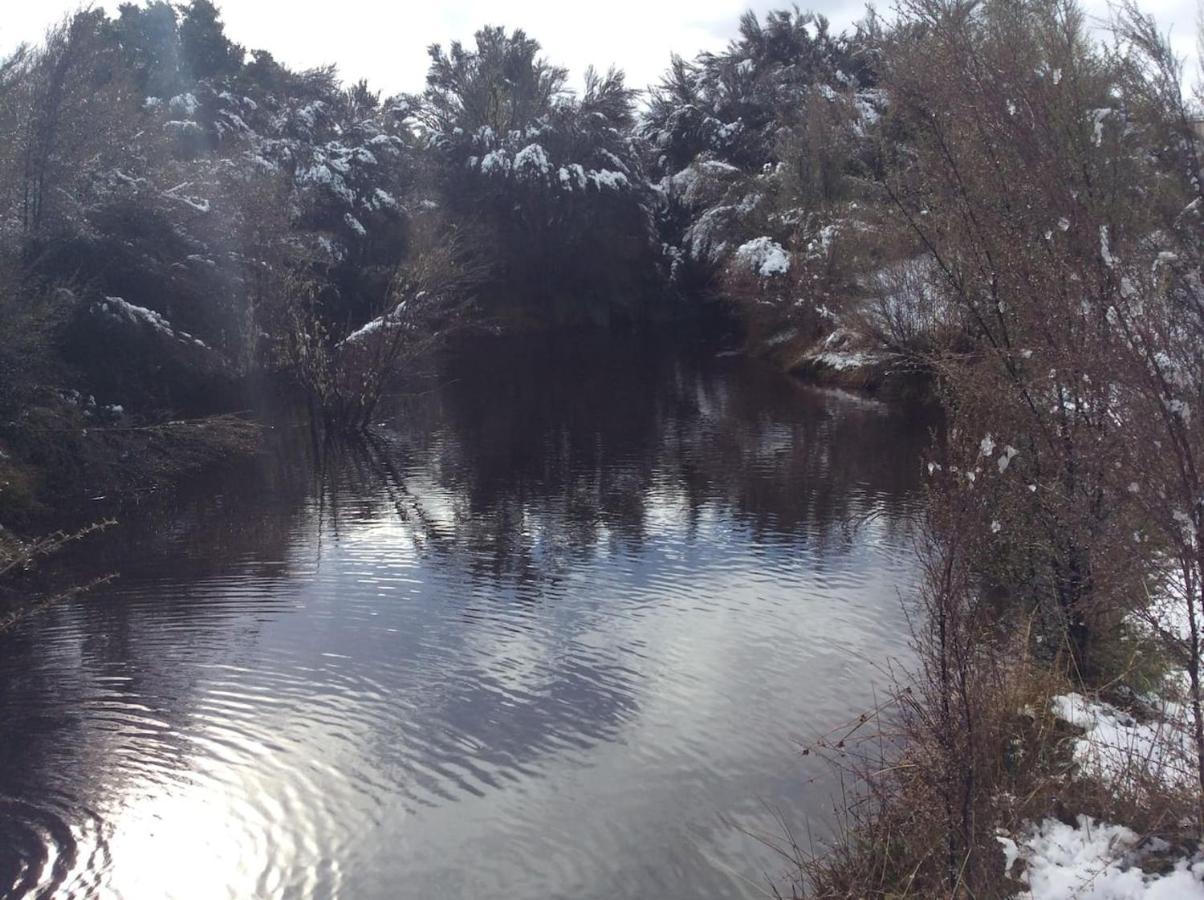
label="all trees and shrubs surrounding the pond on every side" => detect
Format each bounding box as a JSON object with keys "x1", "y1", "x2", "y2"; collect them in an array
[{"x1": 0, "y1": 0, "x2": 1204, "y2": 896}]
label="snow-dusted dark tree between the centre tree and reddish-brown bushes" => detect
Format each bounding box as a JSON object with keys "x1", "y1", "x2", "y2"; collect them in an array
[{"x1": 641, "y1": 11, "x2": 895, "y2": 354}]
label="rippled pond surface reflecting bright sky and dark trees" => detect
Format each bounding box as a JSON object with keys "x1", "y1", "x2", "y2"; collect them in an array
[{"x1": 0, "y1": 339, "x2": 921, "y2": 898}]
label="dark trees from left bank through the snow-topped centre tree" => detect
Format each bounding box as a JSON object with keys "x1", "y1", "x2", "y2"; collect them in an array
[{"x1": 0, "y1": 0, "x2": 679, "y2": 457}]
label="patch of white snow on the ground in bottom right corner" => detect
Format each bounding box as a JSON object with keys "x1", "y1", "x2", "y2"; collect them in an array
[{"x1": 998, "y1": 816, "x2": 1204, "y2": 900}]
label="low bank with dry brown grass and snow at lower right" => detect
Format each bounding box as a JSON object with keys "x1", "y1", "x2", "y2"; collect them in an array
[{"x1": 796, "y1": 596, "x2": 1204, "y2": 900}]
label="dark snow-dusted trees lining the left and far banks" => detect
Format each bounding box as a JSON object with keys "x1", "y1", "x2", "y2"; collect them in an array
[{"x1": 0, "y1": 0, "x2": 883, "y2": 520}]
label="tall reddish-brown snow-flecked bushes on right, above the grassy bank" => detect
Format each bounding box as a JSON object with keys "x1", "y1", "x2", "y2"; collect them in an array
[{"x1": 889, "y1": 0, "x2": 1204, "y2": 828}]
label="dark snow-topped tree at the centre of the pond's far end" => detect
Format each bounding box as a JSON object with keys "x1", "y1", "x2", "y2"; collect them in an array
[{"x1": 418, "y1": 28, "x2": 659, "y2": 321}]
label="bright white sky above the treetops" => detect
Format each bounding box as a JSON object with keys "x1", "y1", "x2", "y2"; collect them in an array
[{"x1": 0, "y1": 0, "x2": 1204, "y2": 94}]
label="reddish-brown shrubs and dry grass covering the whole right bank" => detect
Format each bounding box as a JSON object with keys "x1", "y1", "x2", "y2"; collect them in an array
[{"x1": 794, "y1": 0, "x2": 1204, "y2": 896}]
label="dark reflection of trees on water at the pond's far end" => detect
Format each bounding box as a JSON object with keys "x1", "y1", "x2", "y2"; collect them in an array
[{"x1": 346, "y1": 339, "x2": 928, "y2": 580}]
